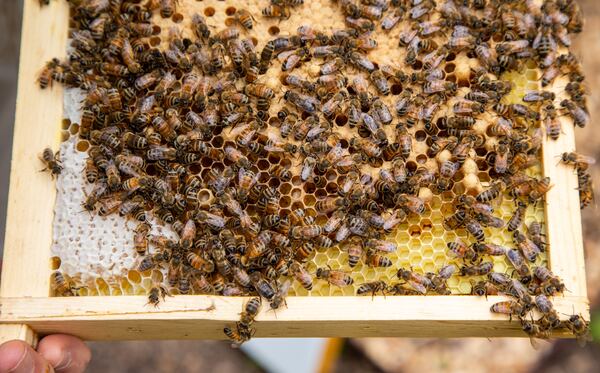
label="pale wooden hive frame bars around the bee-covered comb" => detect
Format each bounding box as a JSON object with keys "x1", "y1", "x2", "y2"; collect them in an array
[{"x1": 0, "y1": 1, "x2": 589, "y2": 344}]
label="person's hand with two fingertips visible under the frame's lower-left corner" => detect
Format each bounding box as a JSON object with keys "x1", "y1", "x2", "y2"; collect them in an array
[{"x1": 0, "y1": 334, "x2": 92, "y2": 373}]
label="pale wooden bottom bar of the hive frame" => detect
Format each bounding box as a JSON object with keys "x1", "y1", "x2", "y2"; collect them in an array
[{"x1": 0, "y1": 295, "x2": 589, "y2": 340}]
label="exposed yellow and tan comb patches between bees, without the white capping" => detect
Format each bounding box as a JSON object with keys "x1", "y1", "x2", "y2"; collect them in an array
[{"x1": 54, "y1": 0, "x2": 546, "y2": 296}]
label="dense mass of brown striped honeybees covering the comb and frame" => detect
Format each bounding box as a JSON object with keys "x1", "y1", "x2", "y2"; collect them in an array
[{"x1": 39, "y1": 0, "x2": 594, "y2": 344}]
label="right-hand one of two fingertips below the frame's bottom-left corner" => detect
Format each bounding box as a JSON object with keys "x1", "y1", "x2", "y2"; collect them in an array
[{"x1": 38, "y1": 334, "x2": 92, "y2": 373}]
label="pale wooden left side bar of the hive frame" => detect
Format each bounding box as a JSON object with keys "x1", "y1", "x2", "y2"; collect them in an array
[{"x1": 0, "y1": 1, "x2": 69, "y2": 297}]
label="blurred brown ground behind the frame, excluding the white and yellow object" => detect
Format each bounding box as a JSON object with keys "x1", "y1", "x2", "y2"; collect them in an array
[{"x1": 0, "y1": 0, "x2": 600, "y2": 373}]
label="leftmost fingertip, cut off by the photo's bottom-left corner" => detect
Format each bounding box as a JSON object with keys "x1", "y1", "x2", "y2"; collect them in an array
[{"x1": 0, "y1": 340, "x2": 53, "y2": 373}]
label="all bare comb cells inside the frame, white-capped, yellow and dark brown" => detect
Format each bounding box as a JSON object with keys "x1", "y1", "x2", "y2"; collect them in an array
[{"x1": 52, "y1": 0, "x2": 546, "y2": 296}]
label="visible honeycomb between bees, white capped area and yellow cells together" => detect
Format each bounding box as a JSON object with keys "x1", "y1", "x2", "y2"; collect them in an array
[{"x1": 52, "y1": 0, "x2": 546, "y2": 296}]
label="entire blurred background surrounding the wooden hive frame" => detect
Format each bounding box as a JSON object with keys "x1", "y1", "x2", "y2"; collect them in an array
[{"x1": 0, "y1": 0, "x2": 600, "y2": 373}]
